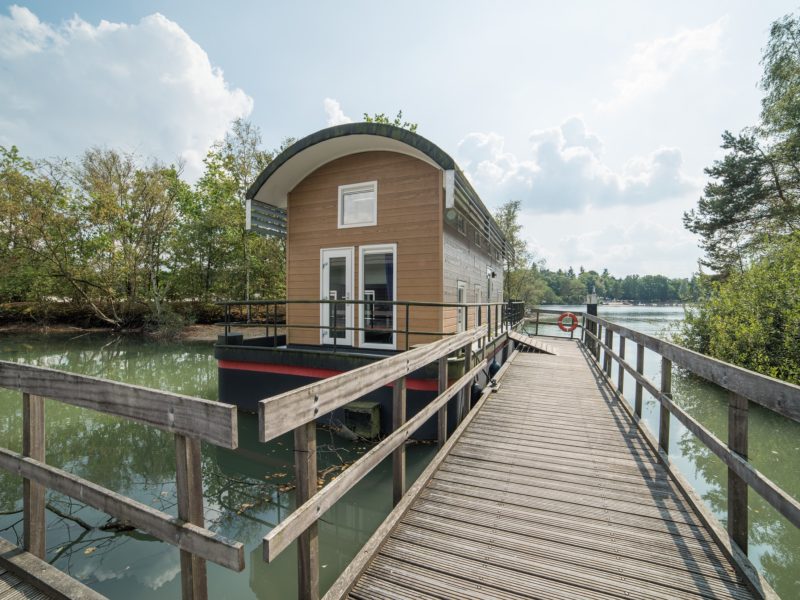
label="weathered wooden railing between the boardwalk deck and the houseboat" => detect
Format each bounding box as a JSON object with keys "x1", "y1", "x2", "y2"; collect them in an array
[{"x1": 258, "y1": 325, "x2": 520, "y2": 599}]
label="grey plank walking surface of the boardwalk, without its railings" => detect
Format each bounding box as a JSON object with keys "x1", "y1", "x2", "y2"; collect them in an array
[{"x1": 350, "y1": 340, "x2": 753, "y2": 600}]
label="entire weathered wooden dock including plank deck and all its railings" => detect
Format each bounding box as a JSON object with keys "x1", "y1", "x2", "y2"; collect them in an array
[{"x1": 0, "y1": 314, "x2": 800, "y2": 600}]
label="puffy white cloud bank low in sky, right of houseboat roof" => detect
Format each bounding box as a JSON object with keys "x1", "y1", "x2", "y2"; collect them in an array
[{"x1": 458, "y1": 117, "x2": 699, "y2": 213}]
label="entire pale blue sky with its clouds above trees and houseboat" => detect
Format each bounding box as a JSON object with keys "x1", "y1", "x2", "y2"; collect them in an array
[{"x1": 0, "y1": 1, "x2": 795, "y2": 276}]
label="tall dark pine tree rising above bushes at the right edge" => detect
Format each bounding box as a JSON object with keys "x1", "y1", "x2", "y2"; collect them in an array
[{"x1": 684, "y1": 15, "x2": 800, "y2": 278}]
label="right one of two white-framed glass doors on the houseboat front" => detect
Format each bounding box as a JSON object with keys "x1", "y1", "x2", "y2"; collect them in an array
[{"x1": 358, "y1": 244, "x2": 397, "y2": 349}]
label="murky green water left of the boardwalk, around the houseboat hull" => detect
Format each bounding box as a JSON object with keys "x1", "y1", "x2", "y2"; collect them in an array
[{"x1": 0, "y1": 334, "x2": 434, "y2": 599}]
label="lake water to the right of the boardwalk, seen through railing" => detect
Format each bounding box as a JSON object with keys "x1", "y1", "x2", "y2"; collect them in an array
[{"x1": 540, "y1": 305, "x2": 800, "y2": 600}]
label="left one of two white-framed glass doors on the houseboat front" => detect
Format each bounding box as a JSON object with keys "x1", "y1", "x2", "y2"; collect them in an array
[{"x1": 320, "y1": 248, "x2": 353, "y2": 346}]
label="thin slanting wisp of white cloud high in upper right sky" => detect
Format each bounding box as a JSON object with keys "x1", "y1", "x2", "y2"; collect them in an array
[{"x1": 597, "y1": 17, "x2": 728, "y2": 110}]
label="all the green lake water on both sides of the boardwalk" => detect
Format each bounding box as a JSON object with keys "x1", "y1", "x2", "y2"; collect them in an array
[{"x1": 0, "y1": 306, "x2": 800, "y2": 599}]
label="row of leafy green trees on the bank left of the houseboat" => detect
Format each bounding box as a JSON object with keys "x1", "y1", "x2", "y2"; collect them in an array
[{"x1": 0, "y1": 120, "x2": 290, "y2": 330}]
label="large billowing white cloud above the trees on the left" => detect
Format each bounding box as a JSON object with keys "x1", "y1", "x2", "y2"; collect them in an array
[{"x1": 0, "y1": 6, "x2": 253, "y2": 178}]
